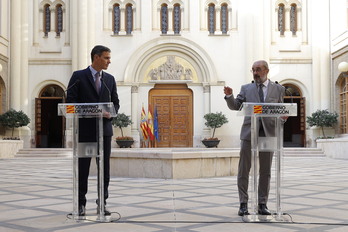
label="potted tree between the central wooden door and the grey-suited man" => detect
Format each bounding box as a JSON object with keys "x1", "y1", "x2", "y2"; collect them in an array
[{"x1": 202, "y1": 112, "x2": 228, "y2": 147}]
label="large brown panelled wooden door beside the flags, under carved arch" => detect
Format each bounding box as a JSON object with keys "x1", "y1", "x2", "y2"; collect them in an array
[{"x1": 149, "y1": 85, "x2": 193, "y2": 147}]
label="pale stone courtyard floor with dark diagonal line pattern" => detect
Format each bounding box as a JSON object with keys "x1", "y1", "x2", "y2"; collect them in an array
[{"x1": 0, "y1": 157, "x2": 348, "y2": 232}]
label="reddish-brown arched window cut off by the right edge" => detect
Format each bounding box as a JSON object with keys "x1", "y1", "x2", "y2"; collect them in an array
[{"x1": 339, "y1": 76, "x2": 348, "y2": 134}]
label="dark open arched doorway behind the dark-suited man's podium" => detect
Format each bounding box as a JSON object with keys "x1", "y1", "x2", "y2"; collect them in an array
[{"x1": 35, "y1": 85, "x2": 65, "y2": 148}]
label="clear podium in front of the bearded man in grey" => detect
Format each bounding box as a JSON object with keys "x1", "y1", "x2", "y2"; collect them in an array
[{"x1": 237, "y1": 102, "x2": 297, "y2": 222}]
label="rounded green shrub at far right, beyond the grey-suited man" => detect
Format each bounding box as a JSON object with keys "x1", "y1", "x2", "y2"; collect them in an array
[{"x1": 307, "y1": 110, "x2": 338, "y2": 139}]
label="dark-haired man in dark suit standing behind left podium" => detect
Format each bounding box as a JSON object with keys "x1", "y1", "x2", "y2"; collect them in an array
[{"x1": 67, "y1": 45, "x2": 120, "y2": 216}]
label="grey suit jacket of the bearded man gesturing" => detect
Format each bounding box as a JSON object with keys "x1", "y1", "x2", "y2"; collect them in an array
[{"x1": 225, "y1": 81, "x2": 285, "y2": 141}]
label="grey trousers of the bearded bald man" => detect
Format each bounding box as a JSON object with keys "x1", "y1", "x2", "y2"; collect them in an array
[{"x1": 237, "y1": 140, "x2": 273, "y2": 204}]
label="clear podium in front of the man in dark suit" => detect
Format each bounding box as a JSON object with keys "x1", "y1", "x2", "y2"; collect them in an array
[{"x1": 58, "y1": 102, "x2": 116, "y2": 222}]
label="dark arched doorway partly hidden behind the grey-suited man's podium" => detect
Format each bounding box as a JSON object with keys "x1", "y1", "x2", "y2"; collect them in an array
[{"x1": 283, "y1": 84, "x2": 306, "y2": 147}]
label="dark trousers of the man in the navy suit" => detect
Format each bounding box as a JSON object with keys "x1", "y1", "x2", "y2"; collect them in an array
[{"x1": 78, "y1": 136, "x2": 111, "y2": 205}]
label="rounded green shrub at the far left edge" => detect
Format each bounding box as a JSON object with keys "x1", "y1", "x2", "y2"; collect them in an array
[{"x1": 0, "y1": 109, "x2": 30, "y2": 140}]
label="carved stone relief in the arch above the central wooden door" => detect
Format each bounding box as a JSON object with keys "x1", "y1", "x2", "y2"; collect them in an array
[{"x1": 148, "y1": 56, "x2": 192, "y2": 80}]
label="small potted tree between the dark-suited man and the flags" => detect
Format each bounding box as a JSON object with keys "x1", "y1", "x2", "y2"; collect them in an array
[{"x1": 112, "y1": 113, "x2": 134, "y2": 148}]
